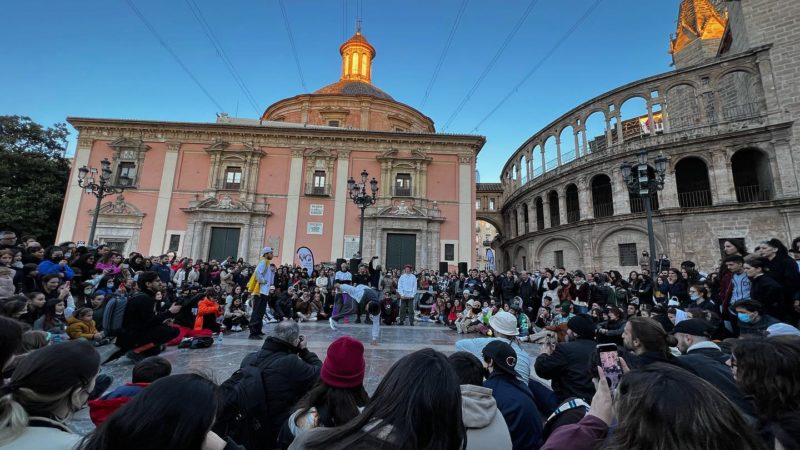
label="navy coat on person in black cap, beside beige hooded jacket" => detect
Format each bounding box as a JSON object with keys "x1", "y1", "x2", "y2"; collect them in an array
[{"x1": 483, "y1": 370, "x2": 542, "y2": 450}]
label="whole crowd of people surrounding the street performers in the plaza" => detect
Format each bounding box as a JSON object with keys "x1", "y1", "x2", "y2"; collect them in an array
[{"x1": 0, "y1": 232, "x2": 800, "y2": 450}]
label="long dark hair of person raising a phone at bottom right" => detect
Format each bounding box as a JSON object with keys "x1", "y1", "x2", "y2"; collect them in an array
[{"x1": 603, "y1": 363, "x2": 765, "y2": 450}]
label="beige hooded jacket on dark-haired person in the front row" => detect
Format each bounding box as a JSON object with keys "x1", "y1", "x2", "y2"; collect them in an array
[{"x1": 461, "y1": 384, "x2": 512, "y2": 450}]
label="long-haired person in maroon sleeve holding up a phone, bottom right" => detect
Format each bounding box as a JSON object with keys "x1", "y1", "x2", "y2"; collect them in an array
[{"x1": 541, "y1": 362, "x2": 766, "y2": 450}]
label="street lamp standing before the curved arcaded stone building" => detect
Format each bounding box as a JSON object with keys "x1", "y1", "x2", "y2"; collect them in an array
[{"x1": 620, "y1": 150, "x2": 667, "y2": 274}]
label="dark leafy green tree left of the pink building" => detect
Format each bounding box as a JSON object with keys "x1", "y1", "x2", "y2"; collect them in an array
[{"x1": 0, "y1": 116, "x2": 70, "y2": 243}]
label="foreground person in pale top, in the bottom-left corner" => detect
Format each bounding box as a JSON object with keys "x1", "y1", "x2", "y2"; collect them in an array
[{"x1": 0, "y1": 342, "x2": 100, "y2": 450}]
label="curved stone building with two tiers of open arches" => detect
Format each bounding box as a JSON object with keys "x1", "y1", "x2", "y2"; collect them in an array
[{"x1": 494, "y1": 0, "x2": 800, "y2": 271}]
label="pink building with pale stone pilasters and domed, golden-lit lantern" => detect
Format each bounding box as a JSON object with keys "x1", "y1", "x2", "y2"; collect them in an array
[{"x1": 58, "y1": 33, "x2": 485, "y2": 268}]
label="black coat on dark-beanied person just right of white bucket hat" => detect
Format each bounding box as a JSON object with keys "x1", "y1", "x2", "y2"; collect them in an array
[{"x1": 533, "y1": 338, "x2": 597, "y2": 402}]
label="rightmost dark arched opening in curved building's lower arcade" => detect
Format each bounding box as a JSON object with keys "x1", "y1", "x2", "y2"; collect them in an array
[{"x1": 731, "y1": 148, "x2": 773, "y2": 203}]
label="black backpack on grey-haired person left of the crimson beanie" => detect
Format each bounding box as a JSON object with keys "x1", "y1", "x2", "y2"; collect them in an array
[{"x1": 212, "y1": 353, "x2": 275, "y2": 449}]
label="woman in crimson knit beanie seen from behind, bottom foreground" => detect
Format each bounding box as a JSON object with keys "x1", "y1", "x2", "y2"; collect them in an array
[{"x1": 278, "y1": 336, "x2": 369, "y2": 449}]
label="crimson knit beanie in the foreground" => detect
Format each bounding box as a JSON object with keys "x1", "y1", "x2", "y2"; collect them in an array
[{"x1": 319, "y1": 336, "x2": 365, "y2": 389}]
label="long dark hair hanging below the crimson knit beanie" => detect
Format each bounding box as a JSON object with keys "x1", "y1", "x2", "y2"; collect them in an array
[{"x1": 295, "y1": 380, "x2": 369, "y2": 428}]
